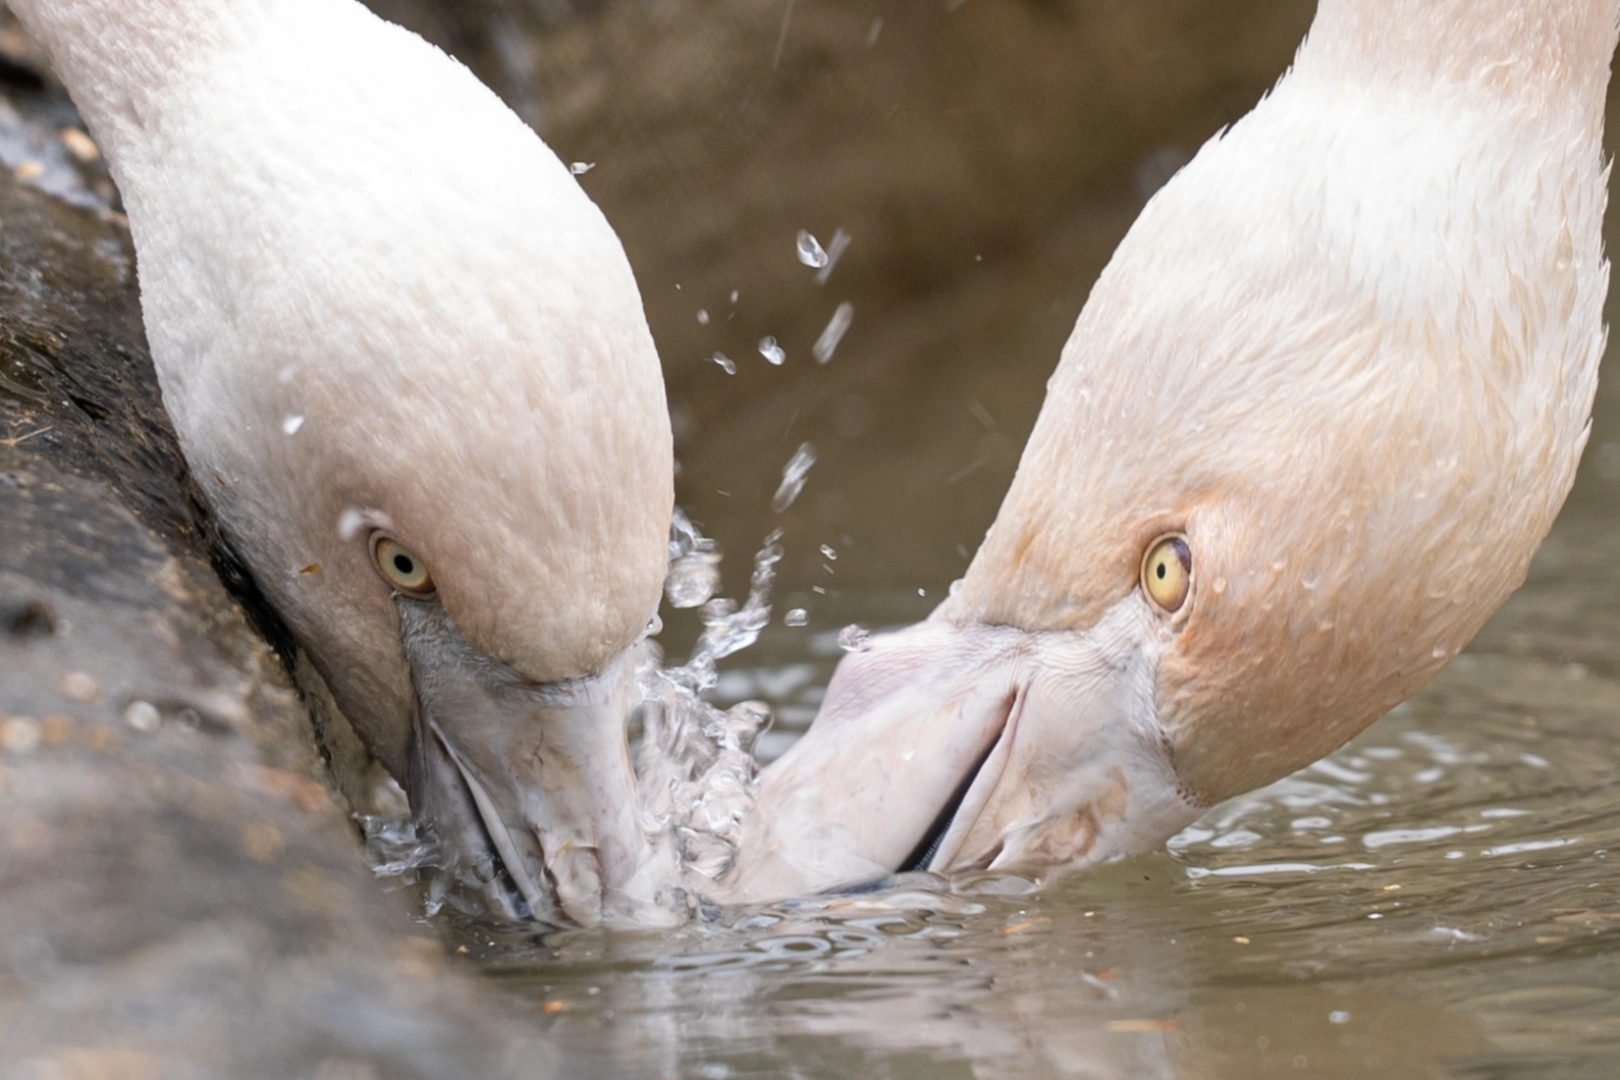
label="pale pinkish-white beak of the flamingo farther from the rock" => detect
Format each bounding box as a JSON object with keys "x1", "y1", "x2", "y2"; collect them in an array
[{"x1": 726, "y1": 596, "x2": 1200, "y2": 900}]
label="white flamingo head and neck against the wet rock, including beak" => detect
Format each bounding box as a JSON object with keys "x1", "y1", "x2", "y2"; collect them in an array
[{"x1": 13, "y1": 0, "x2": 674, "y2": 921}]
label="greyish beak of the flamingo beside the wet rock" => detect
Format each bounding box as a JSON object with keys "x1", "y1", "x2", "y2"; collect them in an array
[{"x1": 399, "y1": 597, "x2": 674, "y2": 926}]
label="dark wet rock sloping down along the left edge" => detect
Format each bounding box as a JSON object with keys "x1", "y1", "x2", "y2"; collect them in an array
[{"x1": 0, "y1": 52, "x2": 554, "y2": 1080}]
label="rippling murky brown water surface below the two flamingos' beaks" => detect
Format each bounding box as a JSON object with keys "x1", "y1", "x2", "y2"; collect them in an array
[{"x1": 471, "y1": 523, "x2": 1620, "y2": 1080}]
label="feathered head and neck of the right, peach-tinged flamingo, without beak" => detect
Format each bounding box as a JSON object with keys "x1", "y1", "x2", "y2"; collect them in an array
[{"x1": 936, "y1": 0, "x2": 1620, "y2": 801}]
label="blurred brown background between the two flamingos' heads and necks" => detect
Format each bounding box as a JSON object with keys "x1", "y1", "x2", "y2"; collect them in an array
[{"x1": 371, "y1": 0, "x2": 1354, "y2": 628}]
